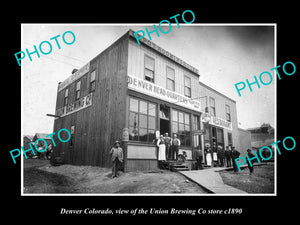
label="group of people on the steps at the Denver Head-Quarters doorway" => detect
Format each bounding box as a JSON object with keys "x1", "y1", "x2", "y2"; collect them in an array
[{"x1": 154, "y1": 133, "x2": 181, "y2": 161}]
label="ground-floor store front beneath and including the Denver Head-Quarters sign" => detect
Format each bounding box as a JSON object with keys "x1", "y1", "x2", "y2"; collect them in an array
[{"x1": 127, "y1": 74, "x2": 201, "y2": 171}]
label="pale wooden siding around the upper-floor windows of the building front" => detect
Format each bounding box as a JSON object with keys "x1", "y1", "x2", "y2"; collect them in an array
[{"x1": 128, "y1": 39, "x2": 240, "y2": 152}]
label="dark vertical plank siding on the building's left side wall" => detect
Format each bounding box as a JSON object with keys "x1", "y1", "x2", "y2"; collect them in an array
[{"x1": 54, "y1": 35, "x2": 128, "y2": 167}]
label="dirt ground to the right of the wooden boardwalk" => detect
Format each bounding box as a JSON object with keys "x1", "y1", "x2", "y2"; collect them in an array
[{"x1": 220, "y1": 163, "x2": 274, "y2": 194}]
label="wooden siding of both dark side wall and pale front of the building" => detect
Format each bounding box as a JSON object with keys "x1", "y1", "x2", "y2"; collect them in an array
[{"x1": 54, "y1": 30, "x2": 239, "y2": 171}]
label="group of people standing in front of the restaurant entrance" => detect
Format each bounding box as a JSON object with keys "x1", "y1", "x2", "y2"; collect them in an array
[{"x1": 202, "y1": 143, "x2": 240, "y2": 172}]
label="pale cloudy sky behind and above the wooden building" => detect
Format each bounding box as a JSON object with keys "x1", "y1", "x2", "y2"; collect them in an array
[{"x1": 22, "y1": 23, "x2": 277, "y2": 135}]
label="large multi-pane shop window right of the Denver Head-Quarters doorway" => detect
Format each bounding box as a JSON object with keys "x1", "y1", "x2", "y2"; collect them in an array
[{"x1": 172, "y1": 110, "x2": 191, "y2": 146}]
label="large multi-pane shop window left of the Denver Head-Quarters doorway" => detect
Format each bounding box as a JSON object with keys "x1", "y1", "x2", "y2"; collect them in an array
[{"x1": 129, "y1": 97, "x2": 156, "y2": 142}]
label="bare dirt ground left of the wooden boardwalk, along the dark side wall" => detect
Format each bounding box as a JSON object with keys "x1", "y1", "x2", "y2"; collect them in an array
[{"x1": 23, "y1": 159, "x2": 207, "y2": 194}]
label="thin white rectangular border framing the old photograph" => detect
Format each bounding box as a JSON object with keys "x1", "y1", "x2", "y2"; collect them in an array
[{"x1": 21, "y1": 23, "x2": 277, "y2": 196}]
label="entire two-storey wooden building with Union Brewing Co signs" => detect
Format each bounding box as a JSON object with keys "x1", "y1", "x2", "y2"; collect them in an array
[{"x1": 52, "y1": 30, "x2": 240, "y2": 171}]
